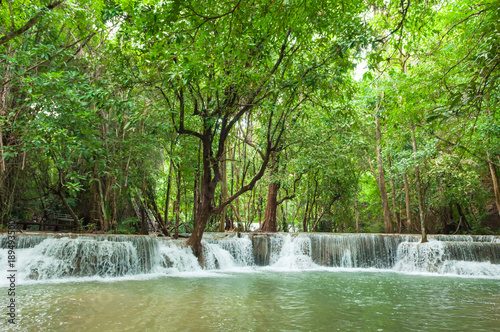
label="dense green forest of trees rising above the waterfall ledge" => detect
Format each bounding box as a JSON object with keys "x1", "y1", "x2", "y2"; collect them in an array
[{"x1": 0, "y1": 0, "x2": 500, "y2": 248}]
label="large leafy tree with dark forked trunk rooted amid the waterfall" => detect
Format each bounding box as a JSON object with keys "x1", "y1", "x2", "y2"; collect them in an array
[{"x1": 119, "y1": 1, "x2": 367, "y2": 257}]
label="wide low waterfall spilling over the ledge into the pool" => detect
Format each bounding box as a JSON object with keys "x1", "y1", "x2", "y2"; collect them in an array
[{"x1": 0, "y1": 233, "x2": 500, "y2": 283}]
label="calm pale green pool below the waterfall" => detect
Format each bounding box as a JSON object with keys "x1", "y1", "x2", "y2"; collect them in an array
[{"x1": 0, "y1": 271, "x2": 500, "y2": 331}]
